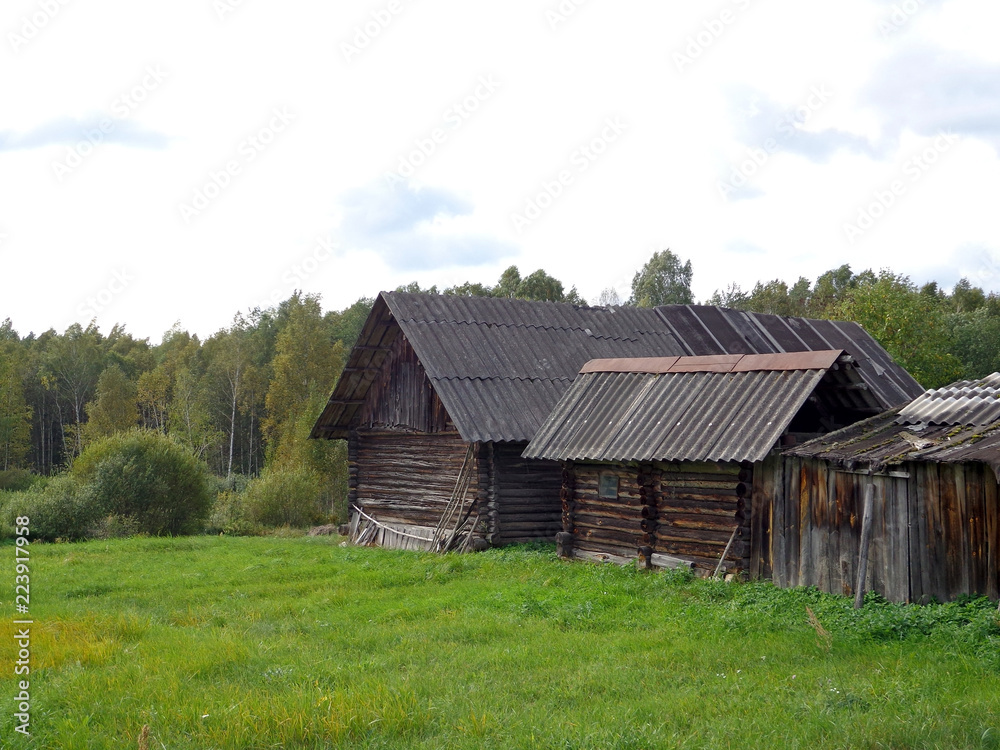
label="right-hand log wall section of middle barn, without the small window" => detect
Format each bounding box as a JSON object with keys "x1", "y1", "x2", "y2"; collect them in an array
[{"x1": 655, "y1": 461, "x2": 754, "y2": 571}]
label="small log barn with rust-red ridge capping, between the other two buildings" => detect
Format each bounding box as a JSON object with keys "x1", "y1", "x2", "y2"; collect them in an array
[{"x1": 524, "y1": 350, "x2": 919, "y2": 576}]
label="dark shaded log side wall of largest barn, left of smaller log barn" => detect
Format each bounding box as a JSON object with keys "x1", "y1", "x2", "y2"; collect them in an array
[{"x1": 488, "y1": 443, "x2": 562, "y2": 545}]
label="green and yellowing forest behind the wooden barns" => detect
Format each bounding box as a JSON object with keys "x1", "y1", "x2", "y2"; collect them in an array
[{"x1": 0, "y1": 250, "x2": 1000, "y2": 536}]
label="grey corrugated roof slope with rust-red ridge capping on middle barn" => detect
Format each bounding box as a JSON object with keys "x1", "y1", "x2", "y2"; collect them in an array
[{"x1": 524, "y1": 349, "x2": 842, "y2": 461}]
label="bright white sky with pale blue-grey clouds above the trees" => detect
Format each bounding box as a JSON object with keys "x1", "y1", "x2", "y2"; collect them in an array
[{"x1": 0, "y1": 0, "x2": 1000, "y2": 343}]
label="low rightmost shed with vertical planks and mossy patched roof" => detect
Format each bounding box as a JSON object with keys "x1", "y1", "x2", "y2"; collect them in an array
[{"x1": 773, "y1": 373, "x2": 1000, "y2": 603}]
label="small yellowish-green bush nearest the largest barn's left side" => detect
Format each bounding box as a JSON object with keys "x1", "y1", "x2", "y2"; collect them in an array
[{"x1": 242, "y1": 469, "x2": 326, "y2": 528}]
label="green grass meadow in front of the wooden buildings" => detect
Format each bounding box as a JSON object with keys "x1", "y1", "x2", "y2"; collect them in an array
[{"x1": 0, "y1": 537, "x2": 1000, "y2": 750}]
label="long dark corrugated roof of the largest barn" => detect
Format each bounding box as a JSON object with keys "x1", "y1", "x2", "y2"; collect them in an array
[{"x1": 312, "y1": 292, "x2": 921, "y2": 442}]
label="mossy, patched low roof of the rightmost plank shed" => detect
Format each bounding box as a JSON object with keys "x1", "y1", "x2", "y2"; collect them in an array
[{"x1": 786, "y1": 373, "x2": 1000, "y2": 481}]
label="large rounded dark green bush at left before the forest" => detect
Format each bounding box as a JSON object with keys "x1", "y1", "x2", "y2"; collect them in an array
[{"x1": 73, "y1": 430, "x2": 212, "y2": 536}]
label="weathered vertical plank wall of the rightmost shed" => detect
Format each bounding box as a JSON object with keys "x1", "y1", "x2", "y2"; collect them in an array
[{"x1": 771, "y1": 458, "x2": 1000, "y2": 602}]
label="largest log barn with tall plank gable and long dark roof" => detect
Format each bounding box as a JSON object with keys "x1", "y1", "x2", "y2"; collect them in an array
[{"x1": 312, "y1": 292, "x2": 919, "y2": 547}]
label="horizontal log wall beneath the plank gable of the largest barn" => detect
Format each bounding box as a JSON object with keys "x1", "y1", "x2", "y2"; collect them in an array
[{"x1": 352, "y1": 430, "x2": 479, "y2": 529}]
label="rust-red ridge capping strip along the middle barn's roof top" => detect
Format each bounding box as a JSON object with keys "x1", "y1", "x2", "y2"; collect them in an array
[{"x1": 580, "y1": 349, "x2": 844, "y2": 375}]
